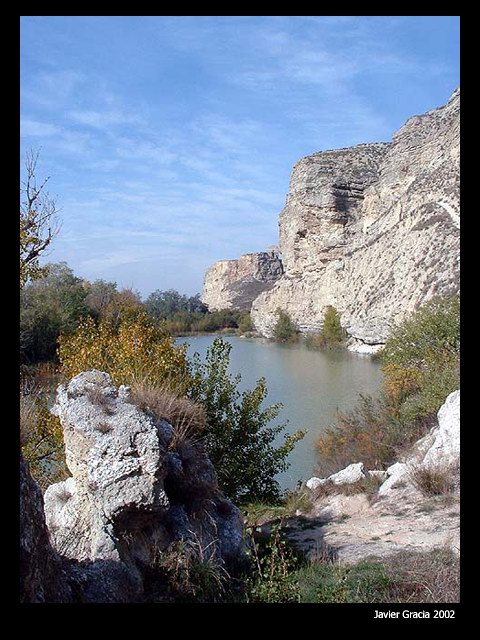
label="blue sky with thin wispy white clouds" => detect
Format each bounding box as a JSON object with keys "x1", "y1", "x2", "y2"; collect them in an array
[{"x1": 20, "y1": 16, "x2": 459, "y2": 296}]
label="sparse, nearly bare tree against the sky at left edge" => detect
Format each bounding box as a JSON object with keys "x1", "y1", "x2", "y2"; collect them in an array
[{"x1": 20, "y1": 151, "x2": 60, "y2": 288}]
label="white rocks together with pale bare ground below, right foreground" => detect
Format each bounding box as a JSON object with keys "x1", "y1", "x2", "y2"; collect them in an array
[{"x1": 287, "y1": 391, "x2": 460, "y2": 563}]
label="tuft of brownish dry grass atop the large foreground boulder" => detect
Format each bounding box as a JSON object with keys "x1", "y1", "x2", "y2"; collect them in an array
[{"x1": 130, "y1": 384, "x2": 206, "y2": 448}]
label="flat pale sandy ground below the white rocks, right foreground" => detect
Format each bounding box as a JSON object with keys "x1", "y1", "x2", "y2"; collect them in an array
[{"x1": 286, "y1": 486, "x2": 460, "y2": 562}]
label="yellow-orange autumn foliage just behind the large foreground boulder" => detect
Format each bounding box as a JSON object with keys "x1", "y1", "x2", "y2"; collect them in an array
[{"x1": 59, "y1": 313, "x2": 189, "y2": 388}]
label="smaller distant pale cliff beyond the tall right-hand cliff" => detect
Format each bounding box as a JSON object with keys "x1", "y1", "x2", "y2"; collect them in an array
[{"x1": 202, "y1": 251, "x2": 283, "y2": 311}]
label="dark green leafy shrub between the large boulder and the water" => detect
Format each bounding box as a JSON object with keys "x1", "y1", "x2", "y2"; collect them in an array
[{"x1": 188, "y1": 338, "x2": 304, "y2": 502}]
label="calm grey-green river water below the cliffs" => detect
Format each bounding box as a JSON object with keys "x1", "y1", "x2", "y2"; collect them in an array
[{"x1": 178, "y1": 335, "x2": 382, "y2": 489}]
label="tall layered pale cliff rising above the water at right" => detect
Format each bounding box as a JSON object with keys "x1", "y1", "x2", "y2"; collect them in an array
[{"x1": 252, "y1": 89, "x2": 460, "y2": 345}]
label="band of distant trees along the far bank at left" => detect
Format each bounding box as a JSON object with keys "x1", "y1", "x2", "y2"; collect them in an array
[{"x1": 20, "y1": 262, "x2": 251, "y2": 365}]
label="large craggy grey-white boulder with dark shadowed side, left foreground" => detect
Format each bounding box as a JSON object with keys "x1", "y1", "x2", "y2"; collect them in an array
[{"x1": 36, "y1": 371, "x2": 243, "y2": 602}]
